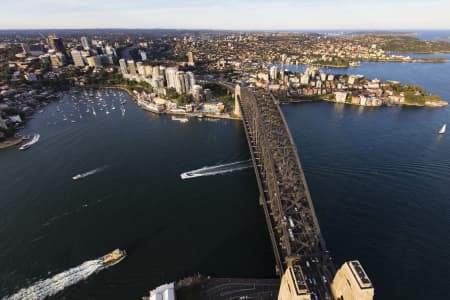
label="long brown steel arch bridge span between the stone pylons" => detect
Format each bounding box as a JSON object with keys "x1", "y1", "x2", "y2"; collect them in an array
[{"x1": 230, "y1": 87, "x2": 336, "y2": 299}]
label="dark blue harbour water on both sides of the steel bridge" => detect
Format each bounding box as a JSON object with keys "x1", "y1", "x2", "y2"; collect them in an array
[{"x1": 0, "y1": 57, "x2": 450, "y2": 300}]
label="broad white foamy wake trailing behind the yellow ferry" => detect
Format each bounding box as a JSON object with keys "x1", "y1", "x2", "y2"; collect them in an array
[{"x1": 3, "y1": 259, "x2": 104, "y2": 300}]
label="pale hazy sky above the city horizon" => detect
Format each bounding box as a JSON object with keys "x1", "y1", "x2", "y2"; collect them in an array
[{"x1": 0, "y1": 0, "x2": 450, "y2": 30}]
